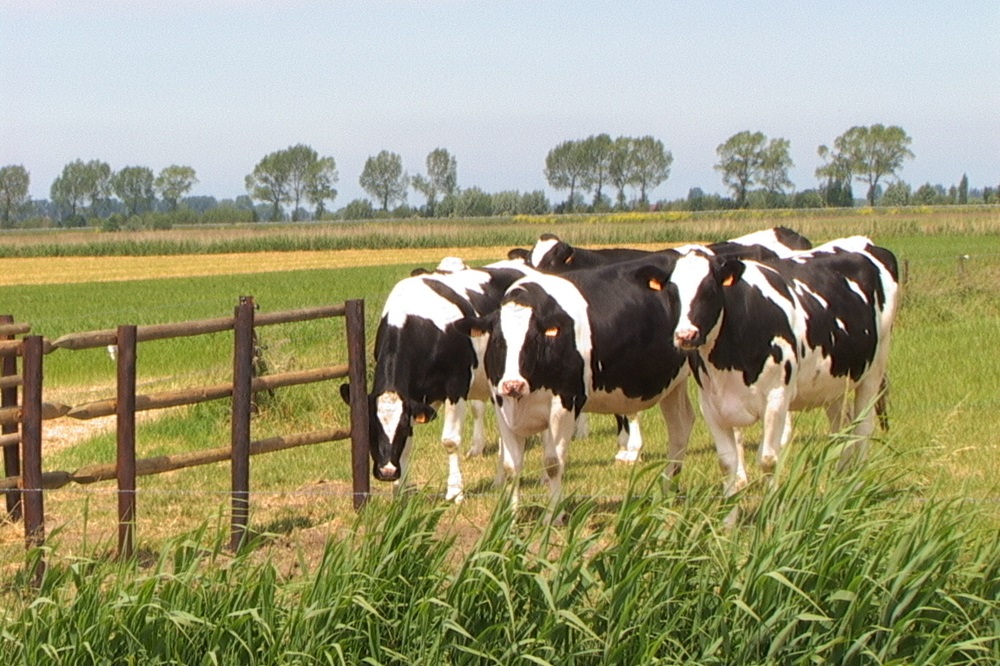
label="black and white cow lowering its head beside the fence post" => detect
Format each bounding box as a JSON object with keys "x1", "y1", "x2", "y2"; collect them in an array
[{"x1": 341, "y1": 261, "x2": 534, "y2": 501}]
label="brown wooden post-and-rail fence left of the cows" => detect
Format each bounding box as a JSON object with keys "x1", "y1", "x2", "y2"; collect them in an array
[{"x1": 0, "y1": 297, "x2": 370, "y2": 574}]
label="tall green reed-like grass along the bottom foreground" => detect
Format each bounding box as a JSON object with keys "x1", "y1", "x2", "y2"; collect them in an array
[{"x1": 0, "y1": 438, "x2": 1000, "y2": 665}]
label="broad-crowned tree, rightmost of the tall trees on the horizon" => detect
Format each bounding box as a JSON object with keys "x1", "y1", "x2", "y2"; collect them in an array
[{"x1": 833, "y1": 125, "x2": 913, "y2": 206}]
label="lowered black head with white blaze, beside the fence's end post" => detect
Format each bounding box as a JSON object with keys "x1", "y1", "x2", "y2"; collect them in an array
[{"x1": 340, "y1": 384, "x2": 437, "y2": 481}]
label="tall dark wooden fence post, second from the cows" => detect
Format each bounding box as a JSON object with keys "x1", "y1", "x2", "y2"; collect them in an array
[{"x1": 229, "y1": 296, "x2": 254, "y2": 552}]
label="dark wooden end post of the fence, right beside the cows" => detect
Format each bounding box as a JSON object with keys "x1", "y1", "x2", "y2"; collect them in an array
[{"x1": 344, "y1": 299, "x2": 371, "y2": 510}]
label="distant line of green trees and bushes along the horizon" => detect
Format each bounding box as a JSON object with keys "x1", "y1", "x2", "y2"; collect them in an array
[{"x1": 0, "y1": 124, "x2": 1000, "y2": 231}]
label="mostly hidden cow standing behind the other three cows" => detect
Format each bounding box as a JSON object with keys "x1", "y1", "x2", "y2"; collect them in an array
[{"x1": 508, "y1": 227, "x2": 812, "y2": 463}]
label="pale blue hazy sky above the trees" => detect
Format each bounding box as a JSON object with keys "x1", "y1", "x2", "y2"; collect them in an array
[{"x1": 0, "y1": 0, "x2": 1000, "y2": 207}]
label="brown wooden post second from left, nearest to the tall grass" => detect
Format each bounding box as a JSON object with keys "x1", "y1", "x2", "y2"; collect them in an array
[{"x1": 21, "y1": 335, "x2": 45, "y2": 586}]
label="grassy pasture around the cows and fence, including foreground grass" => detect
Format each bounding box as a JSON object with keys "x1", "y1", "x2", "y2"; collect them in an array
[{"x1": 0, "y1": 209, "x2": 1000, "y2": 663}]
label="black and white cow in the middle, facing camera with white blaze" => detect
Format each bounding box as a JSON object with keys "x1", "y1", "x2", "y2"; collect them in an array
[{"x1": 455, "y1": 253, "x2": 694, "y2": 510}]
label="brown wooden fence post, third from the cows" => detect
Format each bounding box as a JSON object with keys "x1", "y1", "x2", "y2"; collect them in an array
[{"x1": 115, "y1": 326, "x2": 136, "y2": 559}]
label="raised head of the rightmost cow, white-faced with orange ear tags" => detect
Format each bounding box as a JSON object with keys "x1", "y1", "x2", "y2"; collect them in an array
[{"x1": 636, "y1": 250, "x2": 746, "y2": 351}]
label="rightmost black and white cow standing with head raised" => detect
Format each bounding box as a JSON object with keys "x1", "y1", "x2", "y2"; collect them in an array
[{"x1": 638, "y1": 236, "x2": 898, "y2": 495}]
